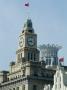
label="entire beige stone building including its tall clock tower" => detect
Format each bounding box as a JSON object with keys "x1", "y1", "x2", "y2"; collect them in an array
[{"x1": 0, "y1": 19, "x2": 58, "y2": 90}]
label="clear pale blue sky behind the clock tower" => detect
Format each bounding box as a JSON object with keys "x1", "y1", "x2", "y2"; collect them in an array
[{"x1": 0, "y1": 0, "x2": 67, "y2": 70}]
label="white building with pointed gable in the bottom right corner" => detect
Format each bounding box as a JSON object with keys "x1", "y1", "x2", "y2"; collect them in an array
[{"x1": 52, "y1": 66, "x2": 67, "y2": 90}]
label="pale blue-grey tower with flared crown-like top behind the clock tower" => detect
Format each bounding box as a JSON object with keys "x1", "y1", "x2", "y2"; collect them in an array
[{"x1": 39, "y1": 44, "x2": 62, "y2": 68}]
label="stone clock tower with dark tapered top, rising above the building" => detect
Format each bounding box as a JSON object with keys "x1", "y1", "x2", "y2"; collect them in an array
[{"x1": 16, "y1": 19, "x2": 39, "y2": 63}]
